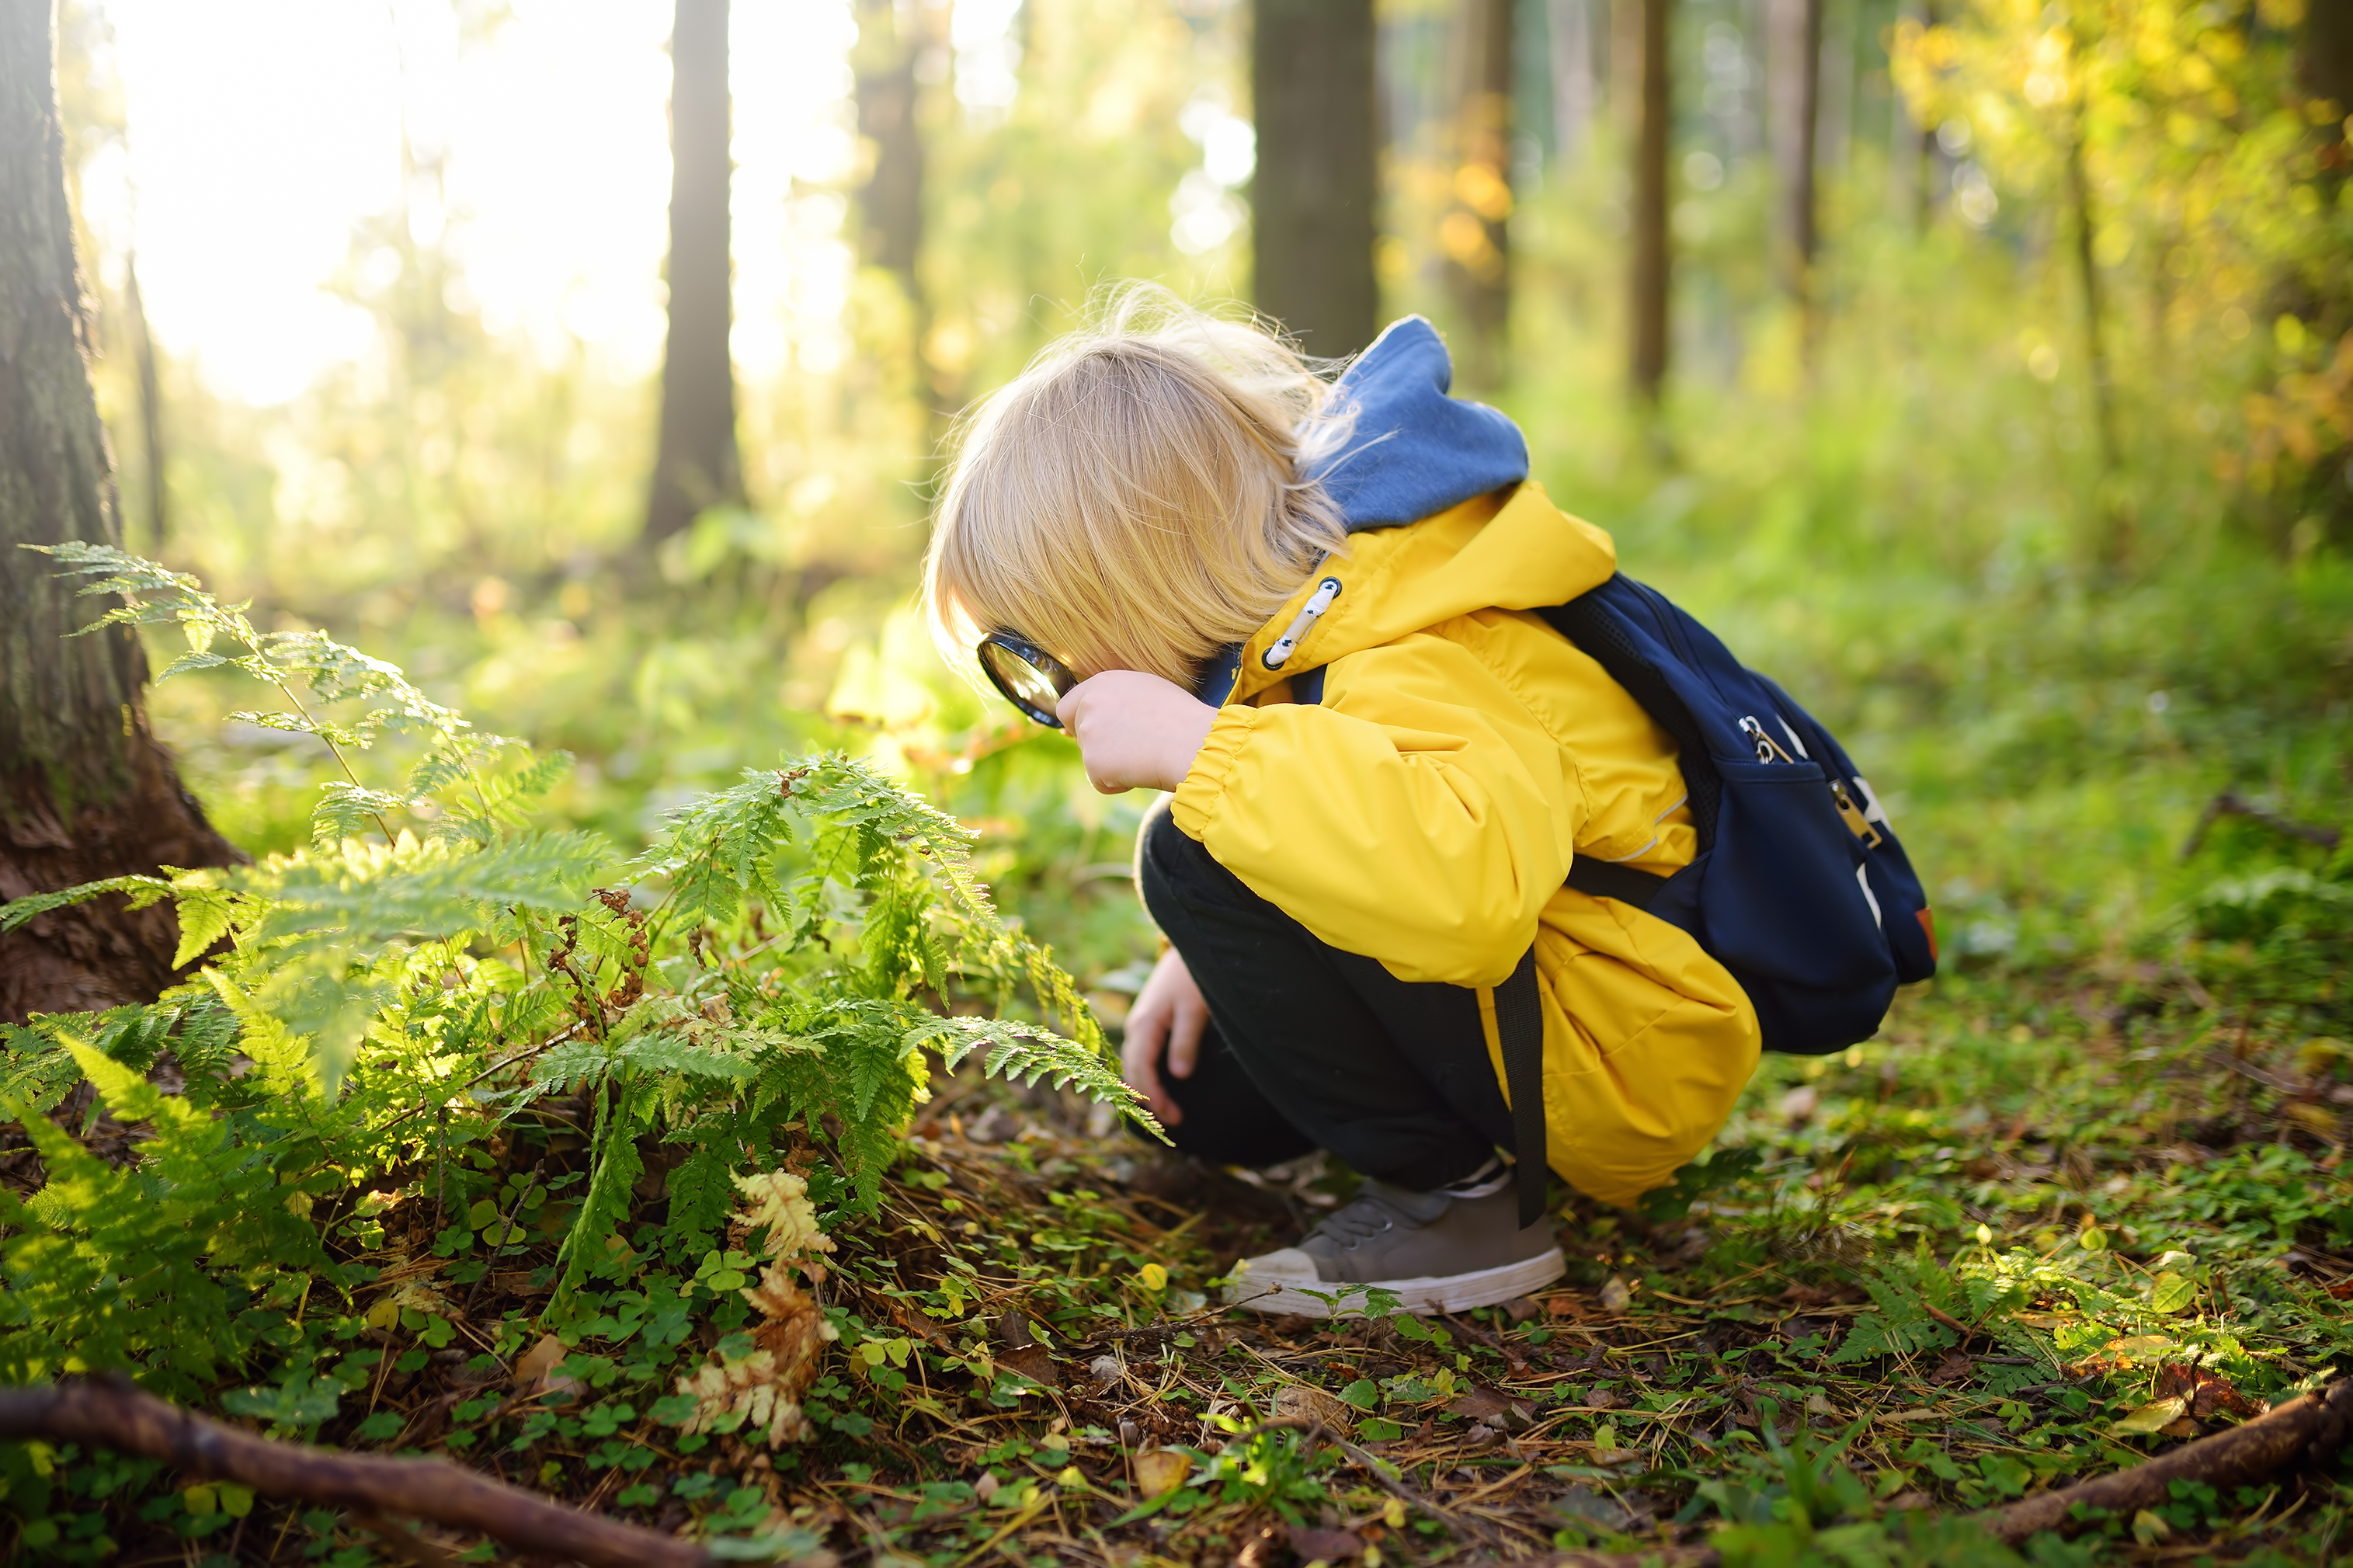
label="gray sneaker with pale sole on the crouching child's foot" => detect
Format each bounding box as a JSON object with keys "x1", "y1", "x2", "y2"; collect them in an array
[{"x1": 1226, "y1": 1177, "x2": 1569, "y2": 1319}]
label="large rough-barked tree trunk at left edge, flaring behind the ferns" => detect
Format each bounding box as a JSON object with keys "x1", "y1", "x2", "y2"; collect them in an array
[{"x1": 0, "y1": 0, "x2": 240, "y2": 1022}]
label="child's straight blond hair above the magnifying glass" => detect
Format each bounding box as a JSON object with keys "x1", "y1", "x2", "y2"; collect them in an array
[{"x1": 923, "y1": 285, "x2": 1348, "y2": 685}]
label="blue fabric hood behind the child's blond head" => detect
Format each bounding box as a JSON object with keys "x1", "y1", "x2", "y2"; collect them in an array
[{"x1": 1309, "y1": 315, "x2": 1527, "y2": 534}]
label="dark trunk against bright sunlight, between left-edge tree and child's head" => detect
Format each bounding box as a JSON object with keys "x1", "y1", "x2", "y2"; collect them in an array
[{"x1": 645, "y1": 0, "x2": 743, "y2": 544}]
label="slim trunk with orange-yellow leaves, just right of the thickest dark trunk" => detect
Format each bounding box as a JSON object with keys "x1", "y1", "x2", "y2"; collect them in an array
[{"x1": 1437, "y1": 0, "x2": 1515, "y2": 391}]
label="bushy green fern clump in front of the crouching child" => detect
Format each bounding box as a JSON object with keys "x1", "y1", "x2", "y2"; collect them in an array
[{"x1": 0, "y1": 544, "x2": 1153, "y2": 1393}]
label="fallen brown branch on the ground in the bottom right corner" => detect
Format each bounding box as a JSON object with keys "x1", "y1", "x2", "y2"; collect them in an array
[{"x1": 1520, "y1": 1379, "x2": 2353, "y2": 1568}]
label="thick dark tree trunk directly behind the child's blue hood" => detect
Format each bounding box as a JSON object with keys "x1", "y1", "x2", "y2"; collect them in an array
[{"x1": 1249, "y1": 0, "x2": 1382, "y2": 356}]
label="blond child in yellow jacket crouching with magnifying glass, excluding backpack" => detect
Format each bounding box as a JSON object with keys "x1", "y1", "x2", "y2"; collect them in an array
[{"x1": 925, "y1": 290, "x2": 1757, "y2": 1316}]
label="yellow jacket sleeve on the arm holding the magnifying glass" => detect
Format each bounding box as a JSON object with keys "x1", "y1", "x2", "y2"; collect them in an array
[{"x1": 1172, "y1": 633, "x2": 1586, "y2": 986}]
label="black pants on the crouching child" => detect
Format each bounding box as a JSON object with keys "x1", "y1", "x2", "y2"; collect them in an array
[{"x1": 1136, "y1": 810, "x2": 1513, "y2": 1191}]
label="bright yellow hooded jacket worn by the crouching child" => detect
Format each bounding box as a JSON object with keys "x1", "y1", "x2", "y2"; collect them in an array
[{"x1": 1172, "y1": 482, "x2": 1757, "y2": 1205}]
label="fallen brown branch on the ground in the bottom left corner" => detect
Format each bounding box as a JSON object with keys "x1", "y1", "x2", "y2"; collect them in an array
[{"x1": 0, "y1": 1375, "x2": 713, "y2": 1568}]
